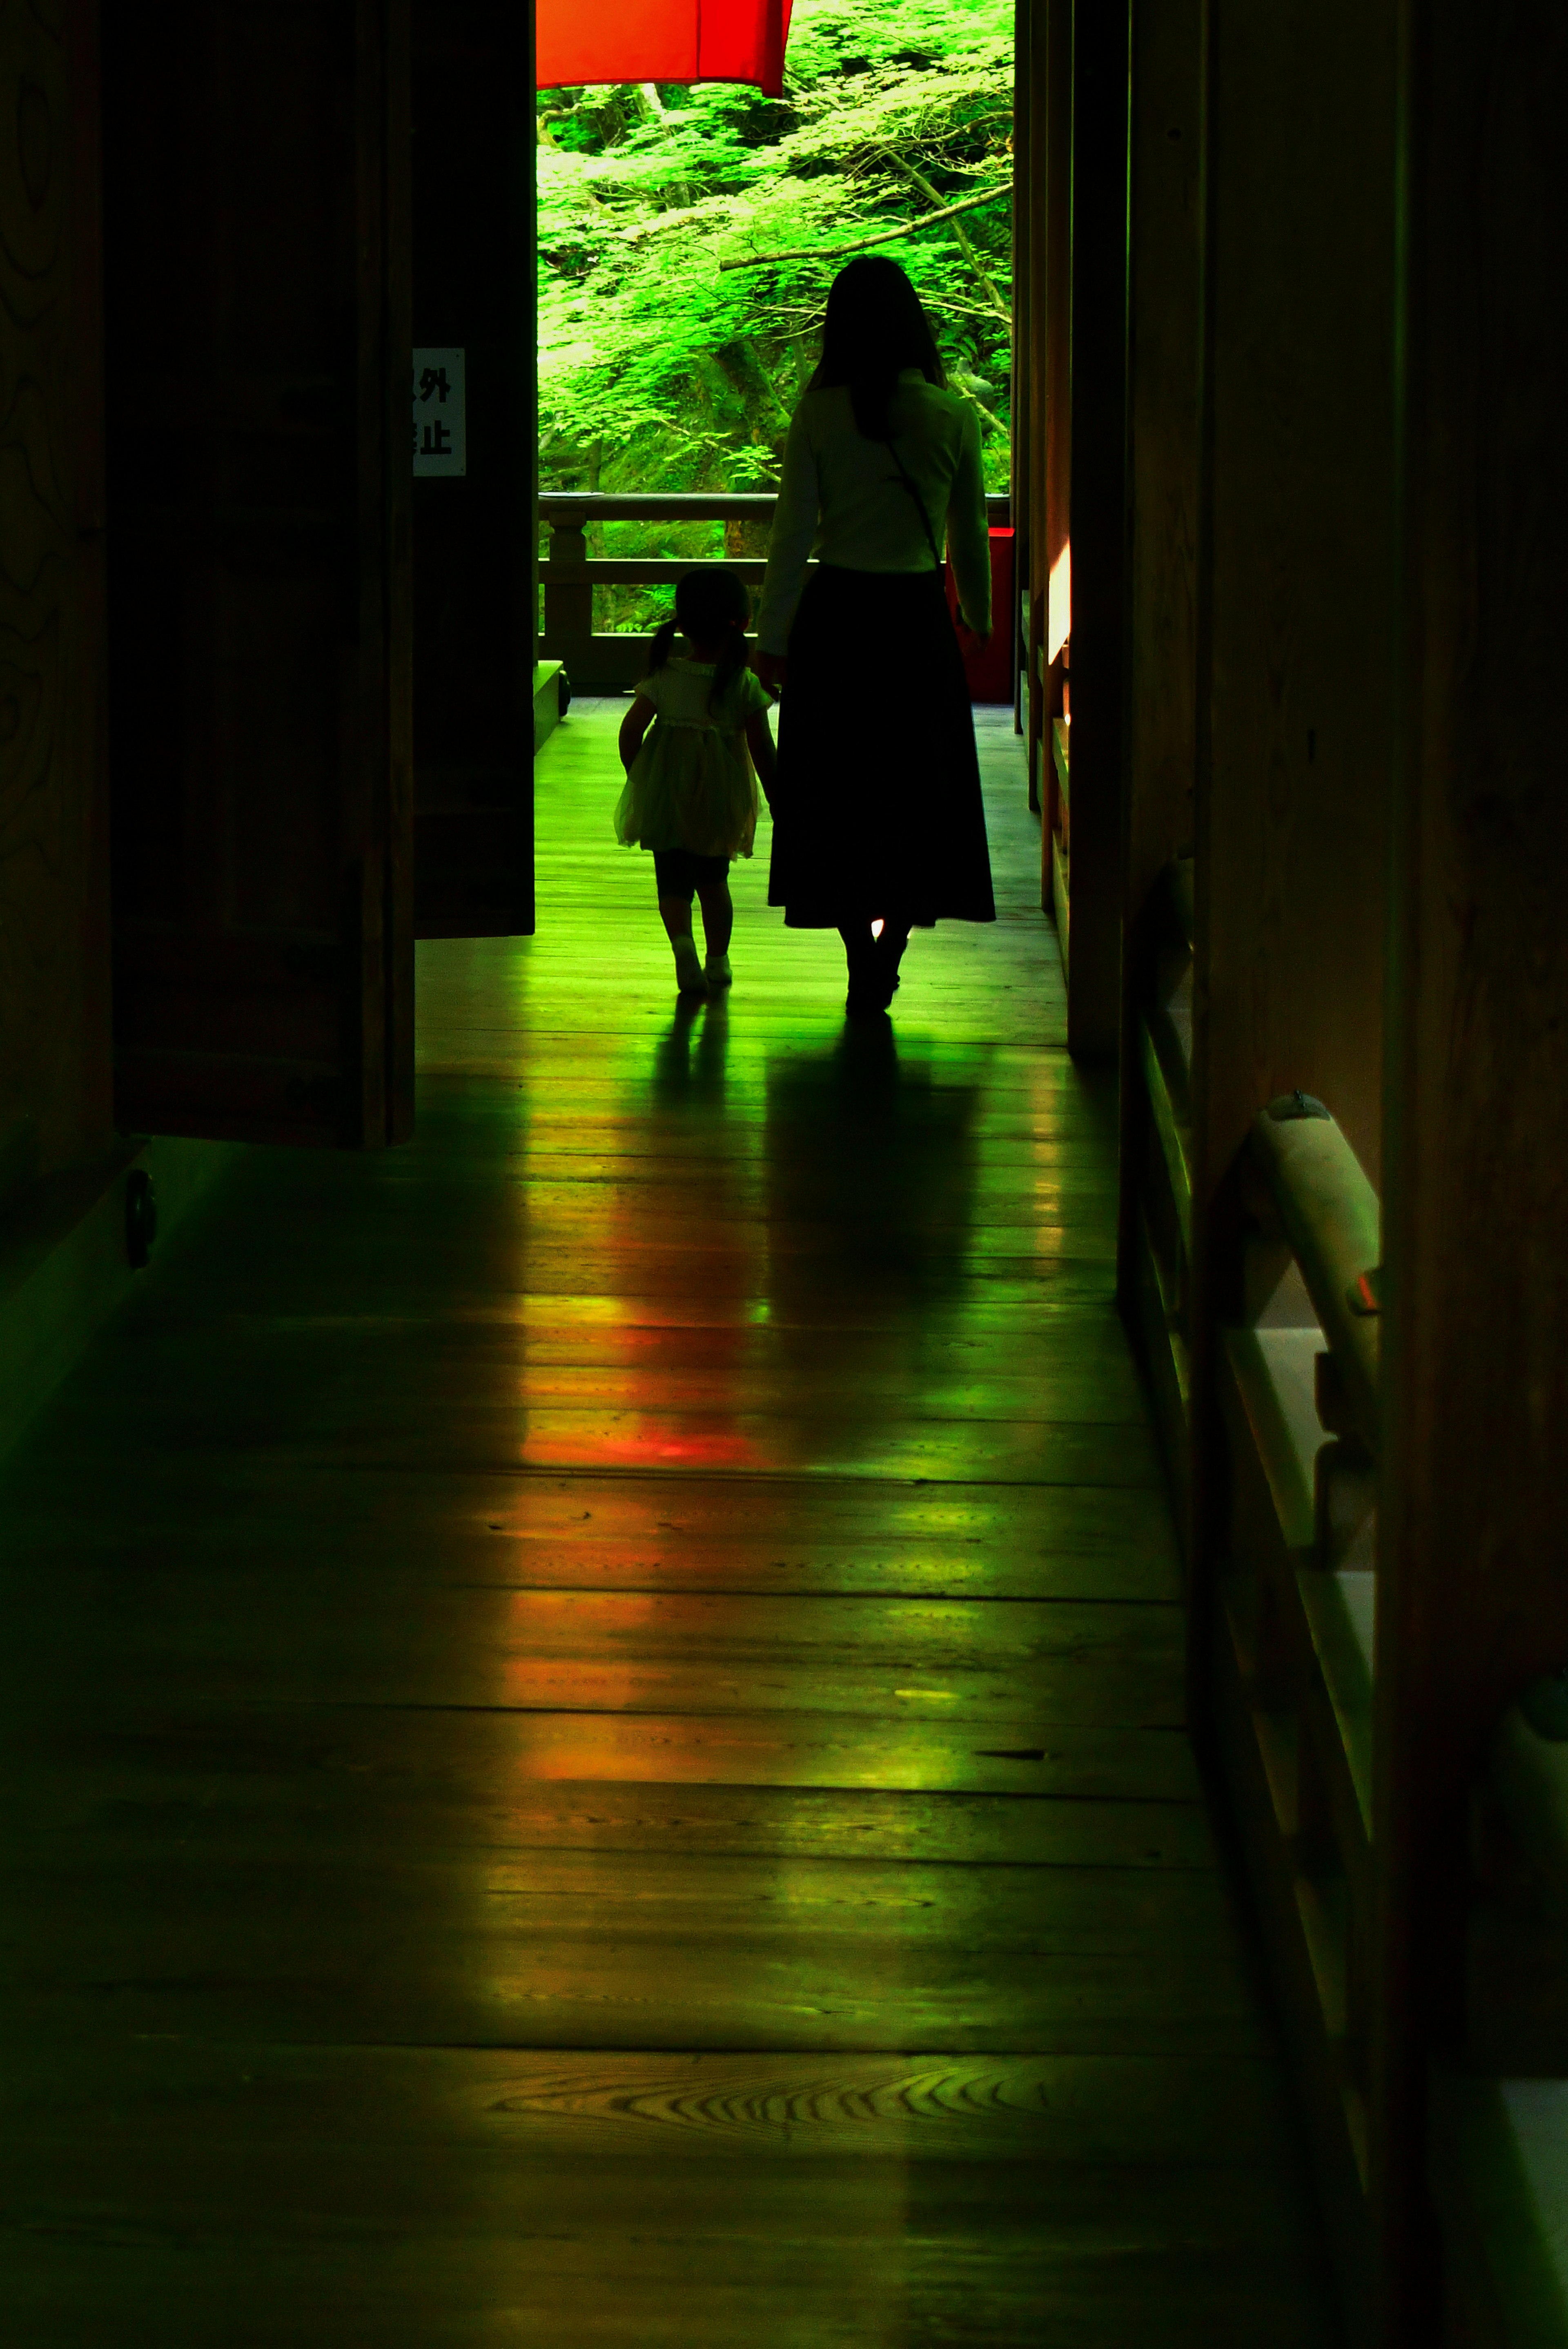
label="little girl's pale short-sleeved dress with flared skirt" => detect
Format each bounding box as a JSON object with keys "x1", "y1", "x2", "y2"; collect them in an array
[{"x1": 615, "y1": 658, "x2": 770, "y2": 857}]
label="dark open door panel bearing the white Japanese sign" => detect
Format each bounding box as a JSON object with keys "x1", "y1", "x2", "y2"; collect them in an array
[{"x1": 413, "y1": 0, "x2": 537, "y2": 937}]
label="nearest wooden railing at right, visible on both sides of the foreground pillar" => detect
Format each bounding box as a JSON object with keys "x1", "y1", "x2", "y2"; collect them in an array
[{"x1": 1216, "y1": 1094, "x2": 1568, "y2": 2349}]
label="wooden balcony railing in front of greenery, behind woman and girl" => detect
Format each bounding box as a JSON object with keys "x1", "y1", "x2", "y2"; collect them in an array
[{"x1": 540, "y1": 491, "x2": 1009, "y2": 693}]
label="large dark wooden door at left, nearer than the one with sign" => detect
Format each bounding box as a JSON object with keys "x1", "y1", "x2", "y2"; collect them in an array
[{"x1": 103, "y1": 0, "x2": 413, "y2": 1144}]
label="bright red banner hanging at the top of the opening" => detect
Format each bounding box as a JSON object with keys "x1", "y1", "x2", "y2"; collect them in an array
[{"x1": 537, "y1": 0, "x2": 791, "y2": 99}]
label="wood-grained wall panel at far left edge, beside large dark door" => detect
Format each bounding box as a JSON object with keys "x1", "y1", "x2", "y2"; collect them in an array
[{"x1": 0, "y1": 0, "x2": 110, "y2": 1184}]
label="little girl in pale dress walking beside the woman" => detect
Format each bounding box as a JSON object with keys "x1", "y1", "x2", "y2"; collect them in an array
[{"x1": 615, "y1": 566, "x2": 772, "y2": 996}]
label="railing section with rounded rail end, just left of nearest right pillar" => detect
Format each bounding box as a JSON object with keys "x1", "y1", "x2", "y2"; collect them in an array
[{"x1": 1214, "y1": 1092, "x2": 1380, "y2": 2283}]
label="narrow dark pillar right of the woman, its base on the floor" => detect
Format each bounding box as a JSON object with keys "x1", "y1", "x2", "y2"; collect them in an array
[{"x1": 1063, "y1": 0, "x2": 1129, "y2": 1055}]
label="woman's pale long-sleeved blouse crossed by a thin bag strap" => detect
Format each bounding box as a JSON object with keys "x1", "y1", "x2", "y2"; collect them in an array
[{"x1": 756, "y1": 369, "x2": 991, "y2": 653}]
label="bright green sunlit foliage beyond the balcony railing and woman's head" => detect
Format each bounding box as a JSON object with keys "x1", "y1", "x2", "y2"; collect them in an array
[{"x1": 537, "y1": 0, "x2": 1014, "y2": 627}]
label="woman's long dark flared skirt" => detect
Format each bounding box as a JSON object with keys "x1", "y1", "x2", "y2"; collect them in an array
[{"x1": 768, "y1": 564, "x2": 995, "y2": 930}]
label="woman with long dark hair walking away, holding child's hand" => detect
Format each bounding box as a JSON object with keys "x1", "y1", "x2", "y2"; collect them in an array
[{"x1": 756, "y1": 256, "x2": 995, "y2": 1017}]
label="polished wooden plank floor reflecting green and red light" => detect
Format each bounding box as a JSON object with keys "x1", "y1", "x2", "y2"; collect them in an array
[{"x1": 0, "y1": 705, "x2": 1338, "y2": 2349}]
